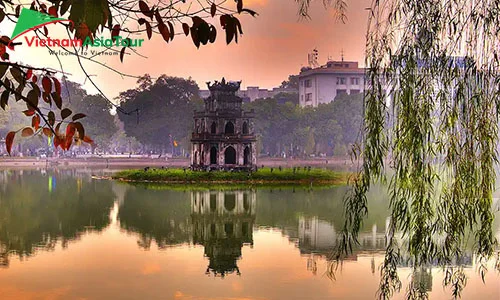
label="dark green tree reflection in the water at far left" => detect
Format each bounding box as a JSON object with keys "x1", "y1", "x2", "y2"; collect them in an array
[{"x1": 0, "y1": 170, "x2": 114, "y2": 267}]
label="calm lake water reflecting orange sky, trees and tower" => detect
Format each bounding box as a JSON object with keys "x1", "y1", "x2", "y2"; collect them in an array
[{"x1": 0, "y1": 170, "x2": 500, "y2": 300}]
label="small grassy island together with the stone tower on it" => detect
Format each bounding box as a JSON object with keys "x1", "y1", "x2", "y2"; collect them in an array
[{"x1": 112, "y1": 78, "x2": 349, "y2": 186}]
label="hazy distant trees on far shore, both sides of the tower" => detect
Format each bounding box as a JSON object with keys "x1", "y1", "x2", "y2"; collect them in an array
[{"x1": 0, "y1": 74, "x2": 363, "y2": 157}]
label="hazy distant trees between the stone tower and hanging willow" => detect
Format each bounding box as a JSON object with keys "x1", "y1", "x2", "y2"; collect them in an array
[{"x1": 245, "y1": 94, "x2": 363, "y2": 157}]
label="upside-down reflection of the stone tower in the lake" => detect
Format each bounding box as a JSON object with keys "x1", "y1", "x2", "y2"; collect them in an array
[{"x1": 191, "y1": 191, "x2": 256, "y2": 277}]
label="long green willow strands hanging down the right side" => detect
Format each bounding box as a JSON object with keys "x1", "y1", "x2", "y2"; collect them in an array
[{"x1": 318, "y1": 0, "x2": 500, "y2": 299}]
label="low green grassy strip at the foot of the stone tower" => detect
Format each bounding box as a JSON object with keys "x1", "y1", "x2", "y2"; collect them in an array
[{"x1": 112, "y1": 167, "x2": 349, "y2": 185}]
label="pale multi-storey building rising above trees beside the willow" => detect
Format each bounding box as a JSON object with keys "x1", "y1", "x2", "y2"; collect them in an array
[{"x1": 299, "y1": 61, "x2": 365, "y2": 107}]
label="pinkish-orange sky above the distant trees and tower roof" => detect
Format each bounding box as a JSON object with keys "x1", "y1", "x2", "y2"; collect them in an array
[{"x1": 0, "y1": 0, "x2": 370, "y2": 98}]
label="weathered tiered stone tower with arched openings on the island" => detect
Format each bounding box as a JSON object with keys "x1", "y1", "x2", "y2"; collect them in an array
[{"x1": 191, "y1": 78, "x2": 257, "y2": 170}]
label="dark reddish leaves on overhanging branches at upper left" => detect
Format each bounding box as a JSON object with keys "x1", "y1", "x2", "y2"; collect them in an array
[{"x1": 0, "y1": 0, "x2": 257, "y2": 153}]
